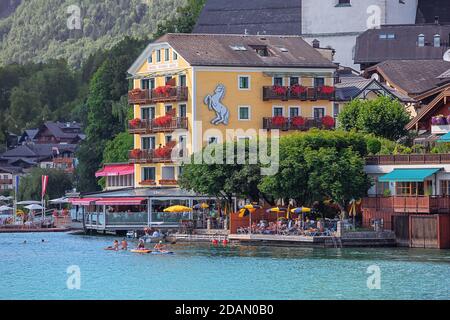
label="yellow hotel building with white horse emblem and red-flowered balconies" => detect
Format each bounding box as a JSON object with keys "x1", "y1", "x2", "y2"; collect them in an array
[{"x1": 128, "y1": 34, "x2": 338, "y2": 188}]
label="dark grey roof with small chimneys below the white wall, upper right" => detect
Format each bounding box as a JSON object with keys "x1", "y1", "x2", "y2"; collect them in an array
[{"x1": 355, "y1": 24, "x2": 450, "y2": 64}]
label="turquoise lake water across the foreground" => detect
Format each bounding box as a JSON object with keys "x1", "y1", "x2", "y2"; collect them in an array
[{"x1": 0, "y1": 233, "x2": 450, "y2": 300}]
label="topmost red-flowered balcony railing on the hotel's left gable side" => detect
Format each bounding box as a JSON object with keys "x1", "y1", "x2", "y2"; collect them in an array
[{"x1": 128, "y1": 87, "x2": 188, "y2": 104}]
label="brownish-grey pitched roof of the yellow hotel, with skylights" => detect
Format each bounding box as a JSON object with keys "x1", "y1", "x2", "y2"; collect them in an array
[{"x1": 153, "y1": 33, "x2": 337, "y2": 68}]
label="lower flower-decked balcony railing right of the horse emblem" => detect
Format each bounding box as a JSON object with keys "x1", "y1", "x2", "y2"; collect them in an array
[{"x1": 263, "y1": 117, "x2": 335, "y2": 131}]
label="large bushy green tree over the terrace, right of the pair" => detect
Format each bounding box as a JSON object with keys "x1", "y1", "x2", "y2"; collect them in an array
[{"x1": 259, "y1": 130, "x2": 370, "y2": 214}]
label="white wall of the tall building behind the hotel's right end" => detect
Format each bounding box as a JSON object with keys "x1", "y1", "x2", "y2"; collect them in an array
[{"x1": 302, "y1": 0, "x2": 418, "y2": 69}]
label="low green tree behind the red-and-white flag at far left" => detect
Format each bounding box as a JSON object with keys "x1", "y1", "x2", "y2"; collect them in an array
[{"x1": 18, "y1": 168, "x2": 72, "y2": 200}]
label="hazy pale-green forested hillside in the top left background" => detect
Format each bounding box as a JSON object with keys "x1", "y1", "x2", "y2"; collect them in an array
[{"x1": 0, "y1": 0, "x2": 187, "y2": 67}]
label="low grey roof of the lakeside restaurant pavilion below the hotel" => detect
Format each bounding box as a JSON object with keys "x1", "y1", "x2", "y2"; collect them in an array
[{"x1": 81, "y1": 187, "x2": 214, "y2": 198}]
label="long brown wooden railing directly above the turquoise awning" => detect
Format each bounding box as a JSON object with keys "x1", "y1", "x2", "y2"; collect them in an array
[{"x1": 366, "y1": 153, "x2": 450, "y2": 165}]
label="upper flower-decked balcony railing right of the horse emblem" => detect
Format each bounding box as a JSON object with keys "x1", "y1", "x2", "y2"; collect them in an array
[{"x1": 263, "y1": 86, "x2": 336, "y2": 101}]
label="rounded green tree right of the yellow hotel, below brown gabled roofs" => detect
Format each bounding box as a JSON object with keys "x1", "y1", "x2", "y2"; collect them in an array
[{"x1": 339, "y1": 96, "x2": 410, "y2": 140}]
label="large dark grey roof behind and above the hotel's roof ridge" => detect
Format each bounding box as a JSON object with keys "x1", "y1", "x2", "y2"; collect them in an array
[{"x1": 193, "y1": 0, "x2": 302, "y2": 35}]
